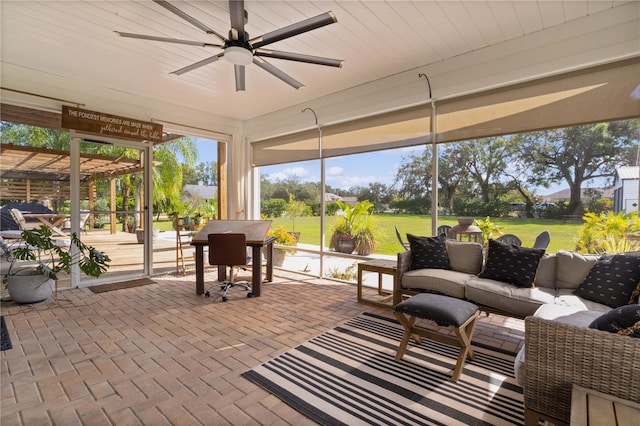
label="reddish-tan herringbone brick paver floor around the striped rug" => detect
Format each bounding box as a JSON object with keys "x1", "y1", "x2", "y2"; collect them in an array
[{"x1": 0, "y1": 271, "x2": 524, "y2": 426}]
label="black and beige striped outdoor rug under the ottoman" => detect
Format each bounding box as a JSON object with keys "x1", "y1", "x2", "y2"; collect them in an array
[{"x1": 243, "y1": 313, "x2": 524, "y2": 426}]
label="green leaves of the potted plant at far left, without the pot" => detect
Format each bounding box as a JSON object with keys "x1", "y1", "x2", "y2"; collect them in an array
[{"x1": 2, "y1": 225, "x2": 111, "y2": 284}]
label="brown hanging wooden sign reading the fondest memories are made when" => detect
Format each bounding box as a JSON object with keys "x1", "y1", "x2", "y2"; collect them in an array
[{"x1": 62, "y1": 105, "x2": 162, "y2": 142}]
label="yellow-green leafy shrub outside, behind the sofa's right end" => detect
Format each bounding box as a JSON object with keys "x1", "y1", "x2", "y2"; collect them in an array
[{"x1": 577, "y1": 212, "x2": 640, "y2": 253}]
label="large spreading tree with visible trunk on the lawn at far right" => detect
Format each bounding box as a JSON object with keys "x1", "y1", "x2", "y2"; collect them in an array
[{"x1": 514, "y1": 120, "x2": 638, "y2": 214}]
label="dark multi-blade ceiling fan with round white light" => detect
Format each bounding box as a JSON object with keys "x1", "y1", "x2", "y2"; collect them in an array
[{"x1": 115, "y1": 0, "x2": 344, "y2": 91}]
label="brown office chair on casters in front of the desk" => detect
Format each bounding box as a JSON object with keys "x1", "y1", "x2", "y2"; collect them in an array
[{"x1": 204, "y1": 233, "x2": 253, "y2": 302}]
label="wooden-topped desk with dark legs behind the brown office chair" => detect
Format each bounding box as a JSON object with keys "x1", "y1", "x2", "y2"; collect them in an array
[{"x1": 191, "y1": 220, "x2": 275, "y2": 297}]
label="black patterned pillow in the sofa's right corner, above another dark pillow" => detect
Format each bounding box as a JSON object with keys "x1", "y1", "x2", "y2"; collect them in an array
[{"x1": 574, "y1": 254, "x2": 640, "y2": 308}]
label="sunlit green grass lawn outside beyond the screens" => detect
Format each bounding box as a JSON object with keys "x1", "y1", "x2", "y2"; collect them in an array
[{"x1": 153, "y1": 213, "x2": 582, "y2": 255}]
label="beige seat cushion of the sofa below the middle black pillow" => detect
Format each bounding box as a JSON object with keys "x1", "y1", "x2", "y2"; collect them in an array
[{"x1": 465, "y1": 277, "x2": 555, "y2": 318}]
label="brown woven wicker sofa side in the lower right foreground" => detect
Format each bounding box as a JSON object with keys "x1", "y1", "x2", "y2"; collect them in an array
[{"x1": 524, "y1": 317, "x2": 640, "y2": 425}]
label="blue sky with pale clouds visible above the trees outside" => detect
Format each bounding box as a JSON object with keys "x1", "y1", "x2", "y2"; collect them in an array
[{"x1": 195, "y1": 138, "x2": 595, "y2": 196}]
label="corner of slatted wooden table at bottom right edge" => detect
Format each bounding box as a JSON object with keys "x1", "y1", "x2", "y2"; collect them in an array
[{"x1": 570, "y1": 385, "x2": 640, "y2": 426}]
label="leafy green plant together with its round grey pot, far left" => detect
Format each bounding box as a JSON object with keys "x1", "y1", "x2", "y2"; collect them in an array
[{"x1": 2, "y1": 225, "x2": 111, "y2": 303}]
